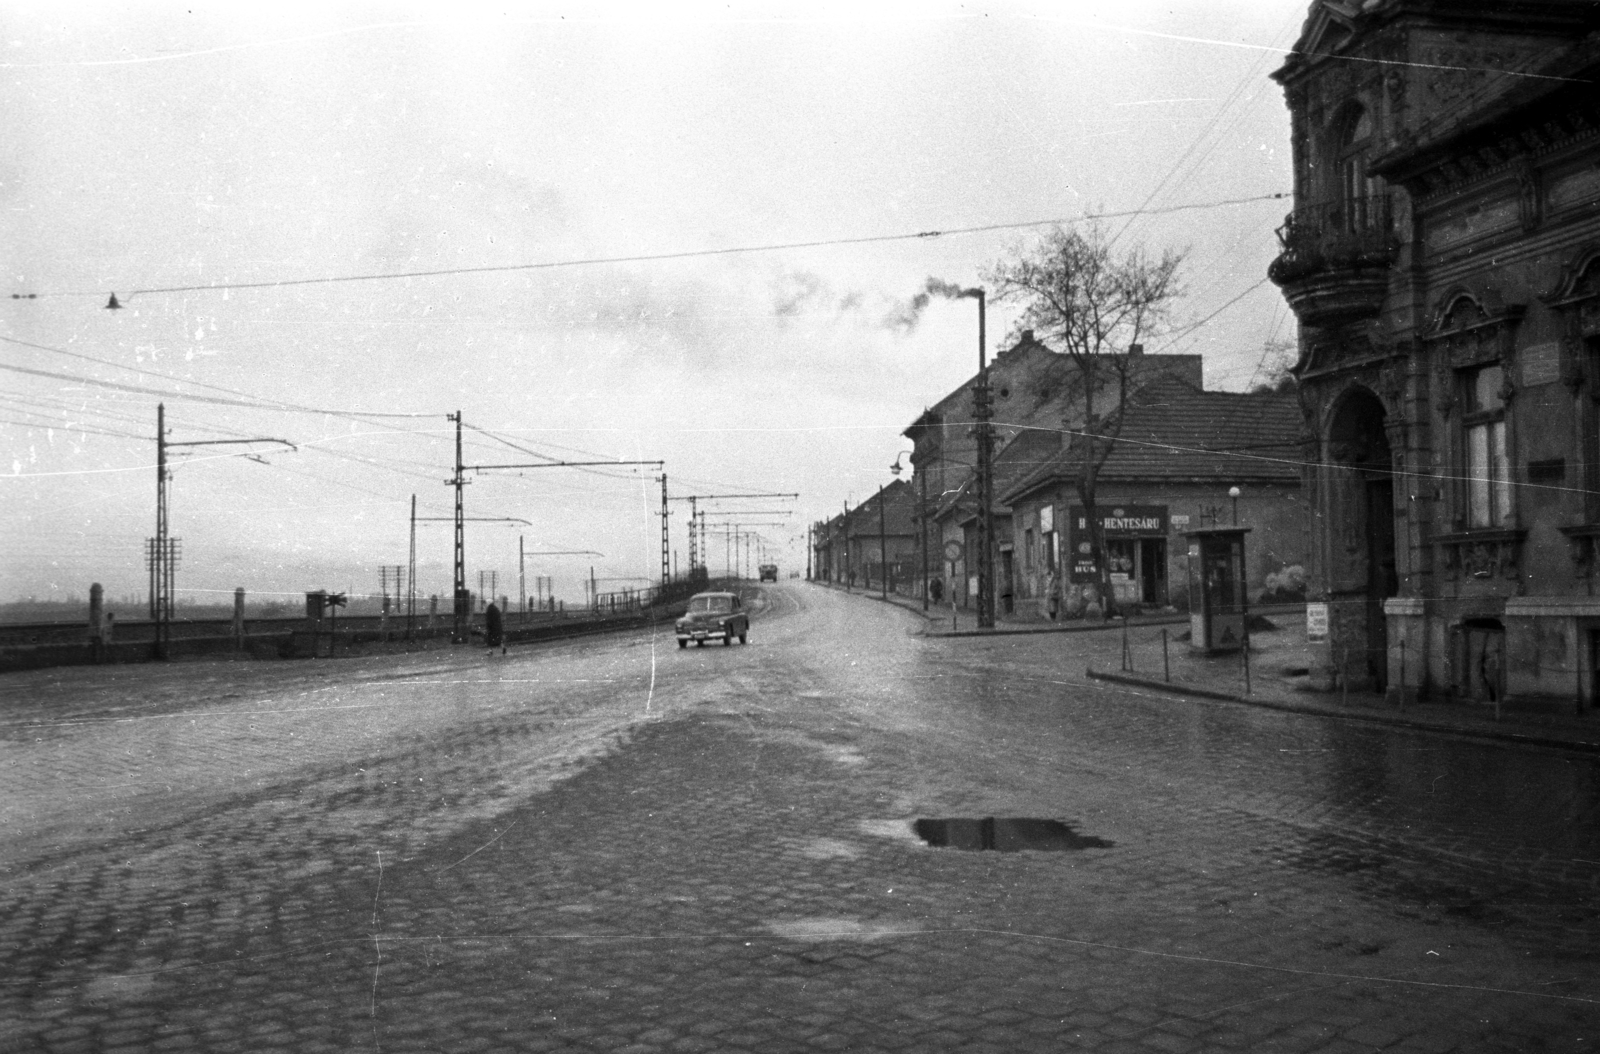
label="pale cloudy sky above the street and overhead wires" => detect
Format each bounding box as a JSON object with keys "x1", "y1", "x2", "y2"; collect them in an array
[{"x1": 0, "y1": 0, "x2": 1306, "y2": 614}]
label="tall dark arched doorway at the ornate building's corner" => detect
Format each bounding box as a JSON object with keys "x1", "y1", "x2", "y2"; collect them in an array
[{"x1": 1328, "y1": 387, "x2": 1400, "y2": 691}]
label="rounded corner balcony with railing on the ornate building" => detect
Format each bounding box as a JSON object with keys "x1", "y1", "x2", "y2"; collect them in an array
[{"x1": 1267, "y1": 195, "x2": 1400, "y2": 326}]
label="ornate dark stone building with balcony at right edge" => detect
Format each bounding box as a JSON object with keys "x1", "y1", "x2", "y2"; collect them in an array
[{"x1": 1269, "y1": 0, "x2": 1600, "y2": 707}]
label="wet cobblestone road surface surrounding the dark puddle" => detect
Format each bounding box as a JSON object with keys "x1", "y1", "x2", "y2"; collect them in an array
[{"x1": 0, "y1": 584, "x2": 1600, "y2": 1052}]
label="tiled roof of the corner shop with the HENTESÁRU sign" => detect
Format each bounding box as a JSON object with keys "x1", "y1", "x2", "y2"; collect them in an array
[{"x1": 995, "y1": 377, "x2": 1304, "y2": 504}]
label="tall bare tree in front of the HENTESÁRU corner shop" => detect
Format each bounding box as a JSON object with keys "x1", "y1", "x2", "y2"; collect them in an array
[{"x1": 984, "y1": 221, "x2": 1184, "y2": 611}]
